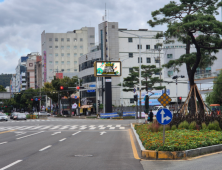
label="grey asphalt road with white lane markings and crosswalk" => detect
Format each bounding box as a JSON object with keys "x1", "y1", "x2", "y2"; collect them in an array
[{"x1": 0, "y1": 118, "x2": 222, "y2": 170}]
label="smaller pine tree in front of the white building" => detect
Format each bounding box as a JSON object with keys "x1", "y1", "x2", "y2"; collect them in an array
[{"x1": 119, "y1": 65, "x2": 165, "y2": 92}]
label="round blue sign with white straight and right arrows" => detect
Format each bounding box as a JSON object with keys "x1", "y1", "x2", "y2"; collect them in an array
[{"x1": 156, "y1": 109, "x2": 173, "y2": 125}]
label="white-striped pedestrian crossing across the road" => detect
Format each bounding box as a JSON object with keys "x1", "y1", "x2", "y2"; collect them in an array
[{"x1": 0, "y1": 125, "x2": 125, "y2": 131}]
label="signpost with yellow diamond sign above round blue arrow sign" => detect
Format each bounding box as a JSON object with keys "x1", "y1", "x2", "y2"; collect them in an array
[{"x1": 156, "y1": 93, "x2": 173, "y2": 145}]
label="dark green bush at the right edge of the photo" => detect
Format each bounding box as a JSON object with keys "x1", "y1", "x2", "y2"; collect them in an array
[{"x1": 206, "y1": 70, "x2": 222, "y2": 105}]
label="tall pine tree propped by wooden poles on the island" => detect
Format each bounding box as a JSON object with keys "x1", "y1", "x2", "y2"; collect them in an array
[{"x1": 148, "y1": 0, "x2": 222, "y2": 116}]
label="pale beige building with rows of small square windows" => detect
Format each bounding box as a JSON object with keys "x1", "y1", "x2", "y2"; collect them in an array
[{"x1": 41, "y1": 27, "x2": 95, "y2": 83}]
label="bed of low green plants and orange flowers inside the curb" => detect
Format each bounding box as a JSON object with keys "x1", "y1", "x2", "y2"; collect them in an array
[{"x1": 135, "y1": 124, "x2": 222, "y2": 151}]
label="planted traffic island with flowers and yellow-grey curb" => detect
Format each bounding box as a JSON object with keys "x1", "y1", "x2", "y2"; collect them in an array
[{"x1": 131, "y1": 124, "x2": 222, "y2": 160}]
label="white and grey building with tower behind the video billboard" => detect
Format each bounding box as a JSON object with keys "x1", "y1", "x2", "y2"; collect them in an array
[{"x1": 79, "y1": 22, "x2": 163, "y2": 106}]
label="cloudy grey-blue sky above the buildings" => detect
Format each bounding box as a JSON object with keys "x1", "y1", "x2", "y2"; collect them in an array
[{"x1": 0, "y1": 0, "x2": 221, "y2": 74}]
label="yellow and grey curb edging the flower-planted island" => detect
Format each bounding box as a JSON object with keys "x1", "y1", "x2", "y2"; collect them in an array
[{"x1": 131, "y1": 123, "x2": 222, "y2": 160}]
